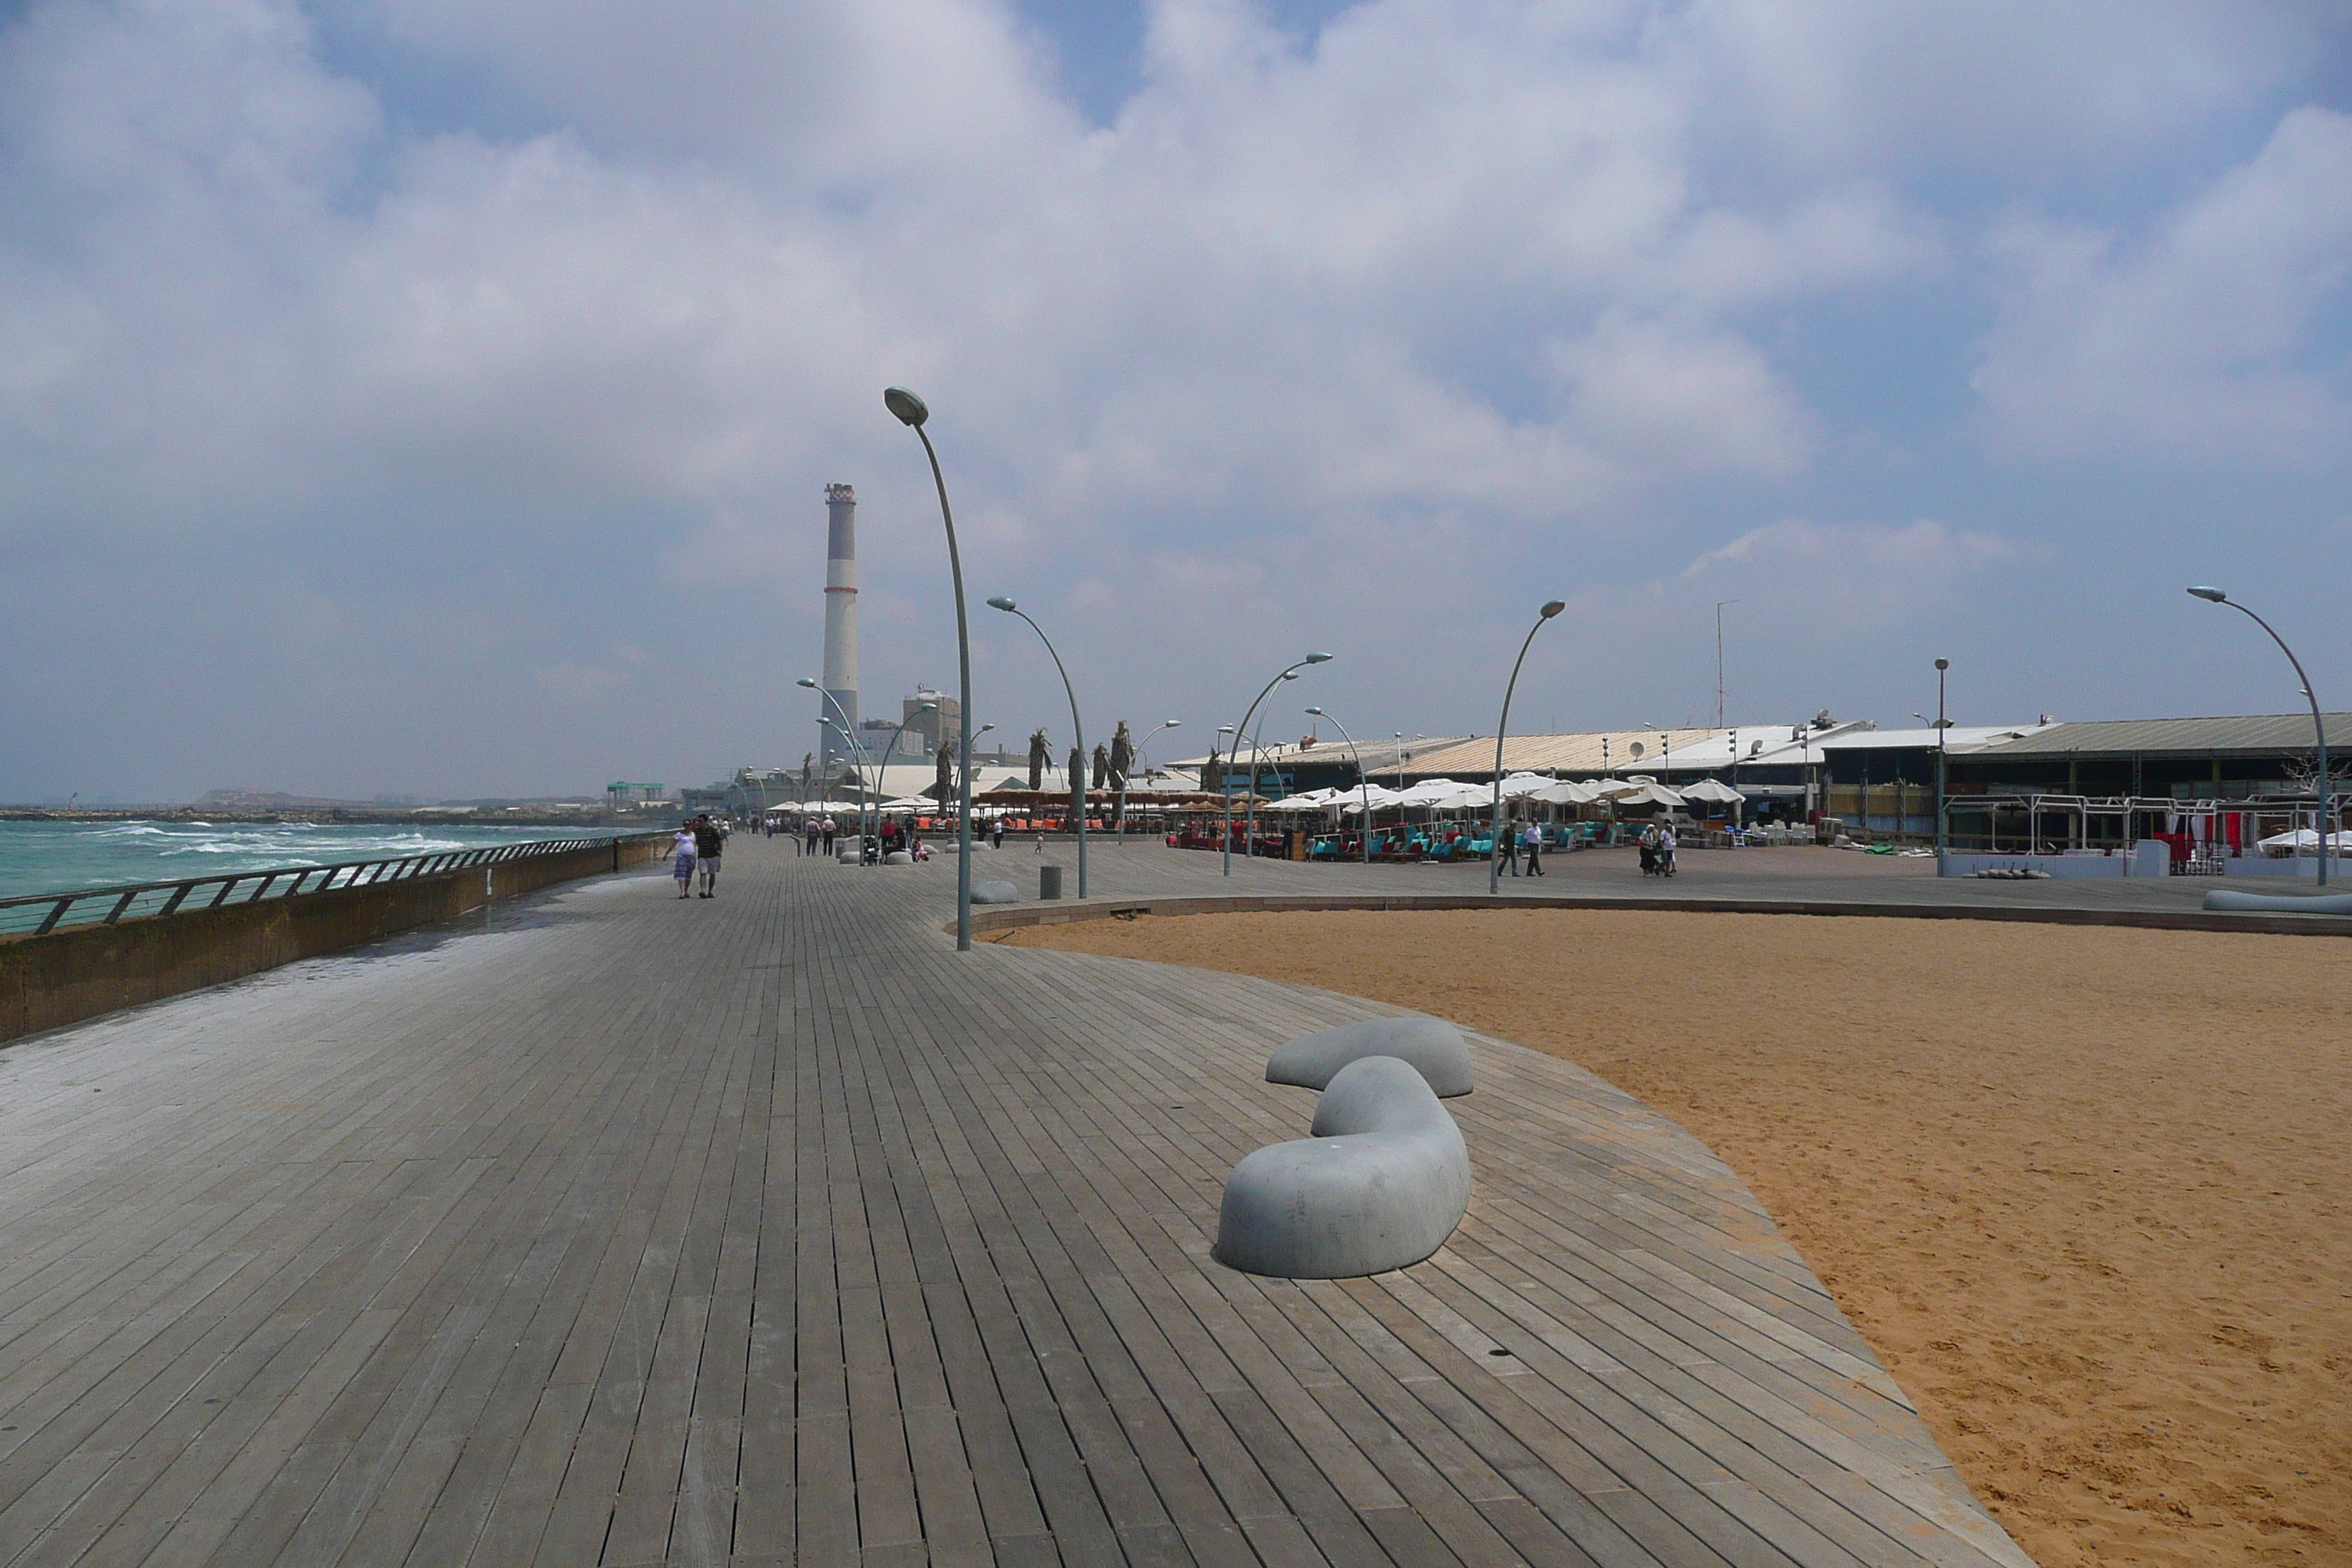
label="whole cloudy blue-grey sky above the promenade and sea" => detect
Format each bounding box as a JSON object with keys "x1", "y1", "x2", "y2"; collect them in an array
[{"x1": 0, "y1": 0, "x2": 2352, "y2": 799}]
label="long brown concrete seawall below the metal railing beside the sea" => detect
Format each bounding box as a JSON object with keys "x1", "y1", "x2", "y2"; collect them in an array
[{"x1": 0, "y1": 834, "x2": 668, "y2": 1041}]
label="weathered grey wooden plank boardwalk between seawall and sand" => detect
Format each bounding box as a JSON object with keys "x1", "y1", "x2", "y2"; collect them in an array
[{"x1": 0, "y1": 840, "x2": 2025, "y2": 1568}]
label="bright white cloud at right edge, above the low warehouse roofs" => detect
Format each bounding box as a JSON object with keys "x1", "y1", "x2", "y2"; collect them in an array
[{"x1": 1973, "y1": 108, "x2": 2352, "y2": 461}]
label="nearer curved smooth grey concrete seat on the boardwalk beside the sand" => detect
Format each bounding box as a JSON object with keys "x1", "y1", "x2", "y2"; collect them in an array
[{"x1": 1213, "y1": 1055, "x2": 1470, "y2": 1279}]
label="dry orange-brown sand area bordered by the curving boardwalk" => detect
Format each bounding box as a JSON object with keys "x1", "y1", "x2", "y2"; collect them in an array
[{"x1": 1009, "y1": 910, "x2": 2352, "y2": 1568}]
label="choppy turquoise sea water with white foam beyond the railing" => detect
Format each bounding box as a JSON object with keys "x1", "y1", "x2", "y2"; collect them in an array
[{"x1": 0, "y1": 823, "x2": 609, "y2": 898}]
